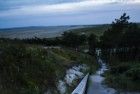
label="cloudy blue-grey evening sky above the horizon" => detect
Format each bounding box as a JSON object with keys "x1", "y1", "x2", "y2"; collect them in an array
[{"x1": 0, "y1": 0, "x2": 140, "y2": 28}]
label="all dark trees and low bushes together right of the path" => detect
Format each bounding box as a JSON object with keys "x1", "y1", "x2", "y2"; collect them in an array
[{"x1": 101, "y1": 13, "x2": 140, "y2": 91}]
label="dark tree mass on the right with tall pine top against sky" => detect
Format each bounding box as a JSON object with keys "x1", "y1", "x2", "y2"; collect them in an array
[{"x1": 101, "y1": 13, "x2": 140, "y2": 61}]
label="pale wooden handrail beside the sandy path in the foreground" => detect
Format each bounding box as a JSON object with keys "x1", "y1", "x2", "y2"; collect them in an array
[{"x1": 71, "y1": 73, "x2": 89, "y2": 94}]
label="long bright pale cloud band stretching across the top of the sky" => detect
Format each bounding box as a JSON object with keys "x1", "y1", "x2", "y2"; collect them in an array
[{"x1": 0, "y1": 0, "x2": 140, "y2": 17}]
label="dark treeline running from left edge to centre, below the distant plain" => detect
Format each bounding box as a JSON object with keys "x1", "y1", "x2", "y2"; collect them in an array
[{"x1": 0, "y1": 31, "x2": 99, "y2": 55}]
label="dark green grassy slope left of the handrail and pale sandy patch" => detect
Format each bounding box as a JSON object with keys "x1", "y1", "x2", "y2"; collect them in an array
[{"x1": 0, "y1": 35, "x2": 97, "y2": 94}]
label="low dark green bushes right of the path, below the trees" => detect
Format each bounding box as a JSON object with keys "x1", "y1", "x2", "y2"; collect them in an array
[{"x1": 105, "y1": 61, "x2": 140, "y2": 92}]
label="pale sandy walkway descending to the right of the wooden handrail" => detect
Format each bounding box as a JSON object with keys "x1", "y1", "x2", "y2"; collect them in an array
[{"x1": 87, "y1": 59, "x2": 116, "y2": 94}]
